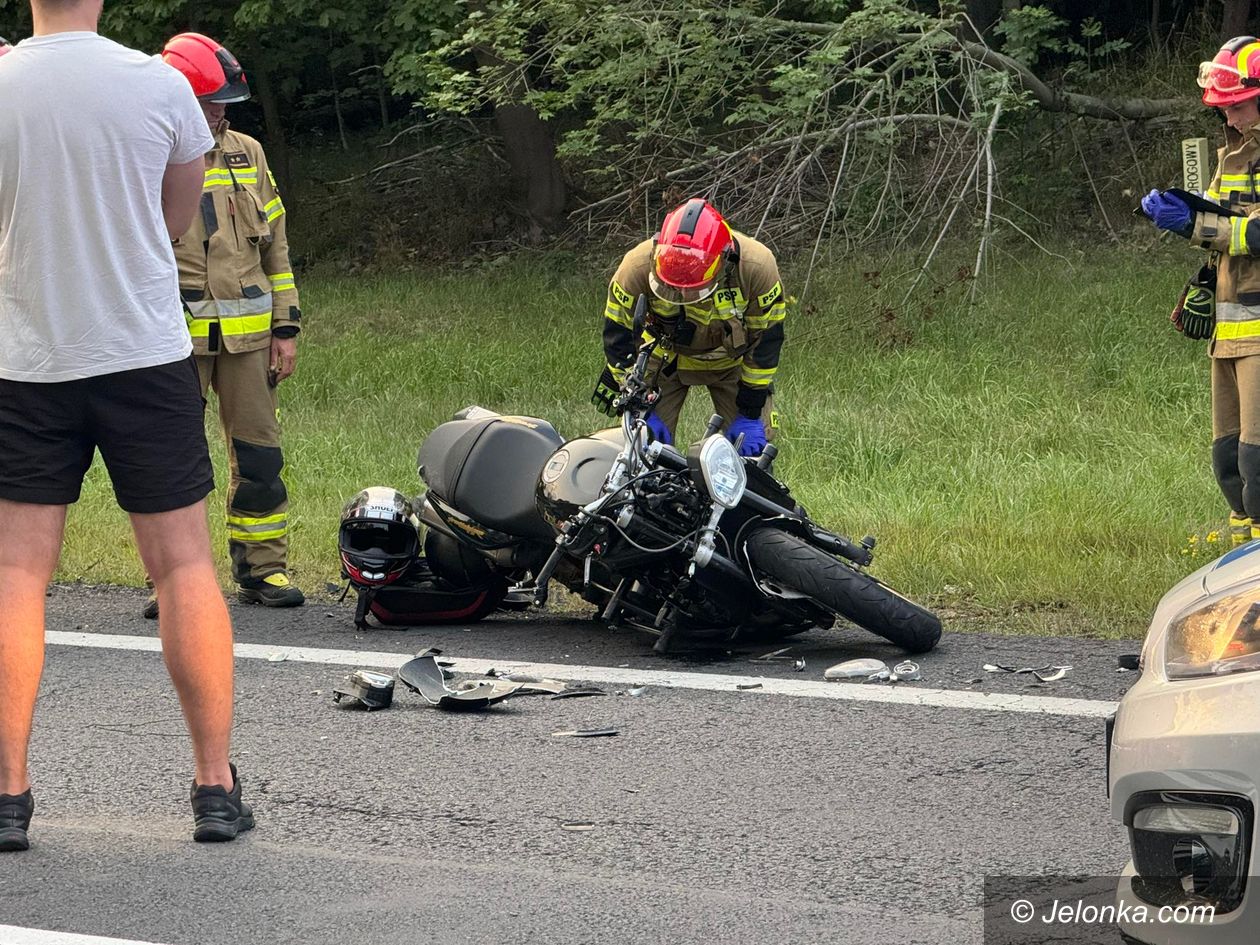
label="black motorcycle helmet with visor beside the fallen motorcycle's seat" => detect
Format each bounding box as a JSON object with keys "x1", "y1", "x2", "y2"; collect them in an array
[{"x1": 336, "y1": 485, "x2": 420, "y2": 587}]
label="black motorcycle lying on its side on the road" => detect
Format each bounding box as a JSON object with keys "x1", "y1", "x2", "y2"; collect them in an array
[{"x1": 417, "y1": 297, "x2": 941, "y2": 653}]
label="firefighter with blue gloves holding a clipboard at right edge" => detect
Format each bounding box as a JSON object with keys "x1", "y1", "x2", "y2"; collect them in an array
[{"x1": 1142, "y1": 37, "x2": 1260, "y2": 544}]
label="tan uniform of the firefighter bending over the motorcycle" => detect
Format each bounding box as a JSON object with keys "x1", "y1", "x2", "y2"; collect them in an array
[{"x1": 604, "y1": 231, "x2": 786, "y2": 440}]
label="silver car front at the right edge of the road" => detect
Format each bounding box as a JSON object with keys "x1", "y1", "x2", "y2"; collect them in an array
[{"x1": 1108, "y1": 542, "x2": 1260, "y2": 945}]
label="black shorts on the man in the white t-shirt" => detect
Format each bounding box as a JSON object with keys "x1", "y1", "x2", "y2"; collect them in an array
[{"x1": 0, "y1": 357, "x2": 214, "y2": 513}]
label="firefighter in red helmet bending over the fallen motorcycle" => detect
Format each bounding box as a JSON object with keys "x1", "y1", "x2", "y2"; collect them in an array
[{"x1": 591, "y1": 197, "x2": 786, "y2": 456}]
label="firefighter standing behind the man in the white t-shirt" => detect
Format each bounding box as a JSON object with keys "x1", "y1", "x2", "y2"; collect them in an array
[{"x1": 145, "y1": 33, "x2": 305, "y2": 616}]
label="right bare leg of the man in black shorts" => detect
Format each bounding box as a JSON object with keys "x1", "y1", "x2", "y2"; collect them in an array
[{"x1": 131, "y1": 500, "x2": 233, "y2": 790}]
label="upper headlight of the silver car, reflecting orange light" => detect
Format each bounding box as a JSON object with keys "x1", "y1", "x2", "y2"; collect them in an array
[{"x1": 1164, "y1": 583, "x2": 1260, "y2": 679}]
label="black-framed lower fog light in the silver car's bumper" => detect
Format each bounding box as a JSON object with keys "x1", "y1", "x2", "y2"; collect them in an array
[{"x1": 1125, "y1": 791, "x2": 1254, "y2": 916}]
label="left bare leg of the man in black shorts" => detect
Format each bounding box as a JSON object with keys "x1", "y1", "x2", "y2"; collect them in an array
[{"x1": 0, "y1": 499, "x2": 66, "y2": 794}]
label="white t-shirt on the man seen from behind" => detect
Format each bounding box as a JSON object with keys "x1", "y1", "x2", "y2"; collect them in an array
[{"x1": 0, "y1": 33, "x2": 214, "y2": 382}]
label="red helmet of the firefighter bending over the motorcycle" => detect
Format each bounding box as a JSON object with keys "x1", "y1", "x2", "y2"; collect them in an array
[{"x1": 648, "y1": 197, "x2": 733, "y2": 305}]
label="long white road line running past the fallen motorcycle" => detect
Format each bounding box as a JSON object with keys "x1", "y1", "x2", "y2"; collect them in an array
[{"x1": 44, "y1": 630, "x2": 1118, "y2": 720}]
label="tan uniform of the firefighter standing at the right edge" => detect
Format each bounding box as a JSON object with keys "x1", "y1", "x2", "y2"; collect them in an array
[{"x1": 1191, "y1": 125, "x2": 1260, "y2": 538}]
